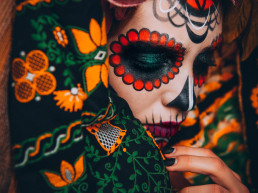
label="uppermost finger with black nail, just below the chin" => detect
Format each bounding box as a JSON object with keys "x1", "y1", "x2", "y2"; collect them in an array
[{"x1": 163, "y1": 146, "x2": 218, "y2": 158}]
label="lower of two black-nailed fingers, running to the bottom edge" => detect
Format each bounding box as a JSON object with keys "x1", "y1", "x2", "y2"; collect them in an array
[{"x1": 165, "y1": 155, "x2": 242, "y2": 192}]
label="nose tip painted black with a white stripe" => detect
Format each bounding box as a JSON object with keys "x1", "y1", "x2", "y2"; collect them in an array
[{"x1": 166, "y1": 76, "x2": 196, "y2": 111}]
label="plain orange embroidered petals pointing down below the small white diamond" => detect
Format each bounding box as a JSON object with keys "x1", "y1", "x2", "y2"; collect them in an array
[{"x1": 85, "y1": 58, "x2": 108, "y2": 92}]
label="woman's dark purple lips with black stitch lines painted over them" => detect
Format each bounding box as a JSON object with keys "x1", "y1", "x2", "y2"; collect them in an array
[{"x1": 144, "y1": 121, "x2": 182, "y2": 138}]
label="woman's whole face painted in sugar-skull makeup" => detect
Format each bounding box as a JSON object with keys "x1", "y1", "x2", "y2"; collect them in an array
[{"x1": 108, "y1": 0, "x2": 222, "y2": 143}]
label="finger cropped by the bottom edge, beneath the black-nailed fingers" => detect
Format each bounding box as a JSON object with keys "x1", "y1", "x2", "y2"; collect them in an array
[{"x1": 179, "y1": 184, "x2": 230, "y2": 193}]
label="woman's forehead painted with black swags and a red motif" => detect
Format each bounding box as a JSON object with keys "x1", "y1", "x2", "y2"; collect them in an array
[{"x1": 115, "y1": 0, "x2": 222, "y2": 49}]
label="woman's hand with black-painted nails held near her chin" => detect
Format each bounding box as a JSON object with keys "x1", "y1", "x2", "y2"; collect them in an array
[{"x1": 163, "y1": 146, "x2": 249, "y2": 193}]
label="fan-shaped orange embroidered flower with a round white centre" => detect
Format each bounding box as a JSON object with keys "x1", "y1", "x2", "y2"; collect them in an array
[{"x1": 53, "y1": 84, "x2": 87, "y2": 112}]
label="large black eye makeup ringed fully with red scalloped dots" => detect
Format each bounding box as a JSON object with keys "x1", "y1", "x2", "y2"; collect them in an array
[{"x1": 109, "y1": 28, "x2": 185, "y2": 91}]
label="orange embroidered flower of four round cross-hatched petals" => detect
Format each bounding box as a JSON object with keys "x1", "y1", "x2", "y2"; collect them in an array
[{"x1": 12, "y1": 50, "x2": 56, "y2": 103}]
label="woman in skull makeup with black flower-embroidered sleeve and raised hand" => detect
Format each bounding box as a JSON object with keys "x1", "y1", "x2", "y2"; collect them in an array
[{"x1": 9, "y1": 0, "x2": 248, "y2": 193}]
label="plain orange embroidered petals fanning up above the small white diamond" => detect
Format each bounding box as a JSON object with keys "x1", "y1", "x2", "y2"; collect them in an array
[{"x1": 71, "y1": 18, "x2": 107, "y2": 54}]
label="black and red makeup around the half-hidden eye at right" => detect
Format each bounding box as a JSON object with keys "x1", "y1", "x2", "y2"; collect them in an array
[{"x1": 193, "y1": 48, "x2": 216, "y2": 87}]
